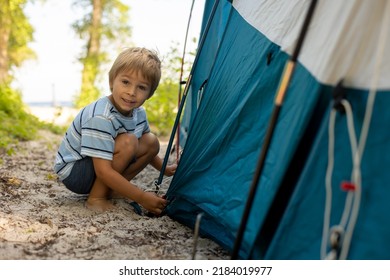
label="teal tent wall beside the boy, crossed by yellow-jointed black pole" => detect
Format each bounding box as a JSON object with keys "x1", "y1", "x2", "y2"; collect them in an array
[{"x1": 167, "y1": 0, "x2": 319, "y2": 258}]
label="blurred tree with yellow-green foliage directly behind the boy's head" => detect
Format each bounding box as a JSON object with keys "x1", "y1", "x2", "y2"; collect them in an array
[{"x1": 73, "y1": 0, "x2": 131, "y2": 108}]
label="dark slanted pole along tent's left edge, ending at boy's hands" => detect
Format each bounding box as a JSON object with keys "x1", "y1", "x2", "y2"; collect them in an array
[{"x1": 154, "y1": 0, "x2": 219, "y2": 192}]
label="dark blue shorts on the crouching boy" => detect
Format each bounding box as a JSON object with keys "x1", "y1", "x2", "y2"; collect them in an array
[{"x1": 62, "y1": 157, "x2": 96, "y2": 194}]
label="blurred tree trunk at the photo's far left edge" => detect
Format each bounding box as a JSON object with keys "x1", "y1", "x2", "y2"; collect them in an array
[{"x1": 0, "y1": 0, "x2": 11, "y2": 84}]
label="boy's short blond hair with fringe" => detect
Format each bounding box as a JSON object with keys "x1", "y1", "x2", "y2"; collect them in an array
[{"x1": 108, "y1": 47, "x2": 161, "y2": 98}]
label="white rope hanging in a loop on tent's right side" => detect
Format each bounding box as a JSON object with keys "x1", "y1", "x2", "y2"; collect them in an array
[{"x1": 321, "y1": 1, "x2": 390, "y2": 259}]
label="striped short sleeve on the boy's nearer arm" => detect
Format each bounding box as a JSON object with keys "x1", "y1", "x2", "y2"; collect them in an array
[{"x1": 81, "y1": 116, "x2": 116, "y2": 160}]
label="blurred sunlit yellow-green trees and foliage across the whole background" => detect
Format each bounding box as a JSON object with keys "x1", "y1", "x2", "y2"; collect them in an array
[{"x1": 0, "y1": 0, "x2": 198, "y2": 153}]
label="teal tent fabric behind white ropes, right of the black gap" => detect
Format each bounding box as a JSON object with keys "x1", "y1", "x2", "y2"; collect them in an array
[{"x1": 266, "y1": 89, "x2": 390, "y2": 260}]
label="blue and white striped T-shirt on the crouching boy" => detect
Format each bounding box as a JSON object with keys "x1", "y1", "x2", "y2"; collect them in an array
[{"x1": 54, "y1": 97, "x2": 150, "y2": 181}]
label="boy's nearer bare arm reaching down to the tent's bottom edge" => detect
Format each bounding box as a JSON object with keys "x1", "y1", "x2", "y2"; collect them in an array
[{"x1": 92, "y1": 158, "x2": 166, "y2": 214}]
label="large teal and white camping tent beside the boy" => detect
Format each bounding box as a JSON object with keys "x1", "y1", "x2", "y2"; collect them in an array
[{"x1": 163, "y1": 0, "x2": 390, "y2": 259}]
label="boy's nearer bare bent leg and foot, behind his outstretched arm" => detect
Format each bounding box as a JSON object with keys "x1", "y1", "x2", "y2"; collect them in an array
[{"x1": 86, "y1": 133, "x2": 138, "y2": 211}]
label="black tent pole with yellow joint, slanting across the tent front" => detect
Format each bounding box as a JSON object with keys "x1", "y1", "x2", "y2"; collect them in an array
[{"x1": 231, "y1": 0, "x2": 317, "y2": 260}]
